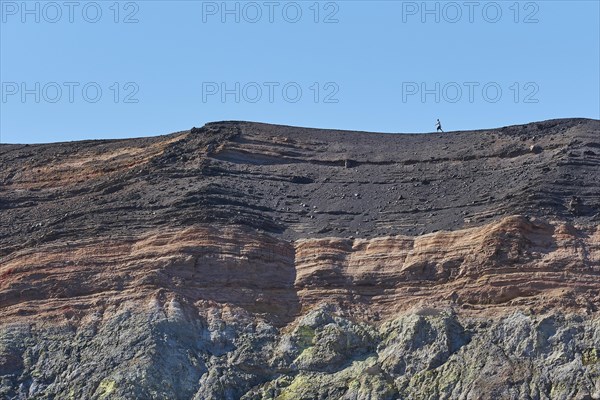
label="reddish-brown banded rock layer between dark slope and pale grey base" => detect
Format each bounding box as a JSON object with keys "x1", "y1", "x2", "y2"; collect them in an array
[{"x1": 0, "y1": 216, "x2": 600, "y2": 323}]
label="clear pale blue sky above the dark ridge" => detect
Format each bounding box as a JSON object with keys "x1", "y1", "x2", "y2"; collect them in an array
[{"x1": 0, "y1": 0, "x2": 600, "y2": 143}]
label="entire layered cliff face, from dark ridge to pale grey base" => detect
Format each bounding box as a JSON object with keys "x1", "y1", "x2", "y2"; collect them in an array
[{"x1": 0, "y1": 120, "x2": 600, "y2": 399}]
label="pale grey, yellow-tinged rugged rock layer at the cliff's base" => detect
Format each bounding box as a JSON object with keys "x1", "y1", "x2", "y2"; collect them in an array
[{"x1": 0, "y1": 299, "x2": 600, "y2": 400}]
